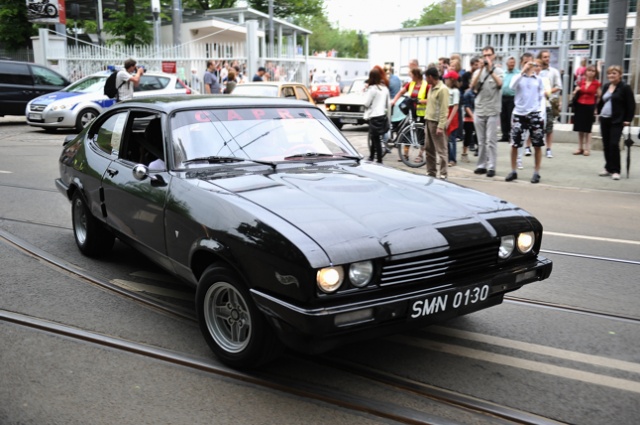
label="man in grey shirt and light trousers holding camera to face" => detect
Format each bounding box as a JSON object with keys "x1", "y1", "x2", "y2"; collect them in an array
[{"x1": 470, "y1": 46, "x2": 504, "y2": 177}]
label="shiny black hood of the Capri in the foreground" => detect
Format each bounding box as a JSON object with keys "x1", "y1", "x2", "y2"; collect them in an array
[{"x1": 204, "y1": 164, "x2": 526, "y2": 264}]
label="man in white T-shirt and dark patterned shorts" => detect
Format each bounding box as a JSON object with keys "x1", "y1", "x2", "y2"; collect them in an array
[{"x1": 505, "y1": 53, "x2": 546, "y2": 183}]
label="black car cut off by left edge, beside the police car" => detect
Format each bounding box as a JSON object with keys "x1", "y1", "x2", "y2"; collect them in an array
[{"x1": 0, "y1": 60, "x2": 71, "y2": 116}]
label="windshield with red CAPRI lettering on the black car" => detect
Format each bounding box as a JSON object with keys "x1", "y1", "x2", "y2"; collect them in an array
[{"x1": 171, "y1": 107, "x2": 360, "y2": 169}]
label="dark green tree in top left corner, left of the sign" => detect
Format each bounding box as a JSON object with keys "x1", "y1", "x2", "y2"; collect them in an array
[{"x1": 0, "y1": 0, "x2": 38, "y2": 50}]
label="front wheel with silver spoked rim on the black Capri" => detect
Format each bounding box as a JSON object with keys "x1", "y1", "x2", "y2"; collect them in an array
[{"x1": 196, "y1": 264, "x2": 282, "y2": 367}]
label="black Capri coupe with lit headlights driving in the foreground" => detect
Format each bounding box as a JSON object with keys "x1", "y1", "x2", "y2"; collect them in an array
[{"x1": 56, "y1": 96, "x2": 552, "y2": 366}]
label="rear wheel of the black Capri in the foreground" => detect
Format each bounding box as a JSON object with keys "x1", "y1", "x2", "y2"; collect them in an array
[{"x1": 71, "y1": 192, "x2": 115, "y2": 257}]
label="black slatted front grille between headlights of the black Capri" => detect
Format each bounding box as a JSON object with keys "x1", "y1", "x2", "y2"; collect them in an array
[{"x1": 380, "y1": 244, "x2": 498, "y2": 286}]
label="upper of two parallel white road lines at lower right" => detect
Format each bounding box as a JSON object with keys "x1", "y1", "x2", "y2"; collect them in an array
[{"x1": 427, "y1": 326, "x2": 640, "y2": 373}]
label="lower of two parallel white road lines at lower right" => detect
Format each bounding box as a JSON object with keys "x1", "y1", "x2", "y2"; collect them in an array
[{"x1": 388, "y1": 335, "x2": 640, "y2": 394}]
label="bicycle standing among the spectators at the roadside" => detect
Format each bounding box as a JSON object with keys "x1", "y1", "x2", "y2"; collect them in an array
[{"x1": 388, "y1": 97, "x2": 427, "y2": 168}]
